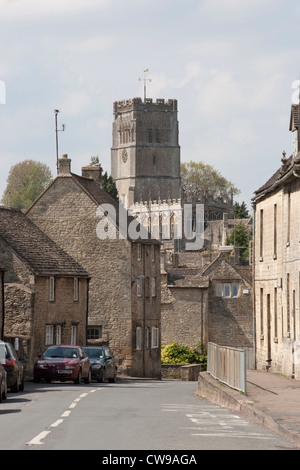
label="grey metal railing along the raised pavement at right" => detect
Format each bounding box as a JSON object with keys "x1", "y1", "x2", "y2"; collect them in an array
[{"x1": 207, "y1": 343, "x2": 246, "y2": 394}]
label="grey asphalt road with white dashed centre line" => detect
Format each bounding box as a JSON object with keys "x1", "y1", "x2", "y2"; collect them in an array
[{"x1": 0, "y1": 379, "x2": 292, "y2": 455}]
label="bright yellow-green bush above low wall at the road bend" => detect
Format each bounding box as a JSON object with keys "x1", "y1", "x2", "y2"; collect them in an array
[{"x1": 161, "y1": 343, "x2": 207, "y2": 369}]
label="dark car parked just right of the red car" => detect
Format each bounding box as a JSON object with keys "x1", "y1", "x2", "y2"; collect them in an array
[{"x1": 84, "y1": 346, "x2": 117, "y2": 383}]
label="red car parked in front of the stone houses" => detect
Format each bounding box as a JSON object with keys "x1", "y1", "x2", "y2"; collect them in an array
[{"x1": 33, "y1": 345, "x2": 91, "y2": 384}]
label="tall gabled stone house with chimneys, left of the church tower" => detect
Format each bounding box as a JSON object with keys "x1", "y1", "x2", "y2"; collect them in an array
[{"x1": 27, "y1": 155, "x2": 161, "y2": 377}]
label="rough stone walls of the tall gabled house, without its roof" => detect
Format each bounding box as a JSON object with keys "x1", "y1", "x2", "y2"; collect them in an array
[{"x1": 27, "y1": 175, "x2": 160, "y2": 376}]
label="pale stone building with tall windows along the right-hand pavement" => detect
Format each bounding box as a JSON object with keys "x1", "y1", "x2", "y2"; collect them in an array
[{"x1": 254, "y1": 105, "x2": 300, "y2": 379}]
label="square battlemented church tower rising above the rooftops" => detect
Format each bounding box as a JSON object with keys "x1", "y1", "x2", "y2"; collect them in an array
[{"x1": 111, "y1": 98, "x2": 180, "y2": 208}]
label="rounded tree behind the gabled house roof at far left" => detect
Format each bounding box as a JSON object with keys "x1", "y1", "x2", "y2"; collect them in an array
[{"x1": 1, "y1": 160, "x2": 52, "y2": 209}]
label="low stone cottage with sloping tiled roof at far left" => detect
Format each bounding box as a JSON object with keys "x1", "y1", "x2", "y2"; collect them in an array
[{"x1": 0, "y1": 207, "x2": 89, "y2": 374}]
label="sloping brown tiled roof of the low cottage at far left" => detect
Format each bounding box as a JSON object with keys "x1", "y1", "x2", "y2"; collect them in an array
[{"x1": 0, "y1": 207, "x2": 88, "y2": 277}]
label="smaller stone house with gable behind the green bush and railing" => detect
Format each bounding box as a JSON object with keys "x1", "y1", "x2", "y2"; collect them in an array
[{"x1": 162, "y1": 253, "x2": 254, "y2": 366}]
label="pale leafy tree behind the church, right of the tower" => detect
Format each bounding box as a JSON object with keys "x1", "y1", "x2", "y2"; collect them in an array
[{"x1": 181, "y1": 161, "x2": 240, "y2": 199}]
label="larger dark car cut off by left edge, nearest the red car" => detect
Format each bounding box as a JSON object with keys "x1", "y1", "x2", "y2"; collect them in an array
[{"x1": 0, "y1": 341, "x2": 24, "y2": 392}]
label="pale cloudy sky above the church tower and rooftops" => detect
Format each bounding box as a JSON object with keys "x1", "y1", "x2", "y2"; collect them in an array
[{"x1": 0, "y1": 0, "x2": 300, "y2": 209}]
